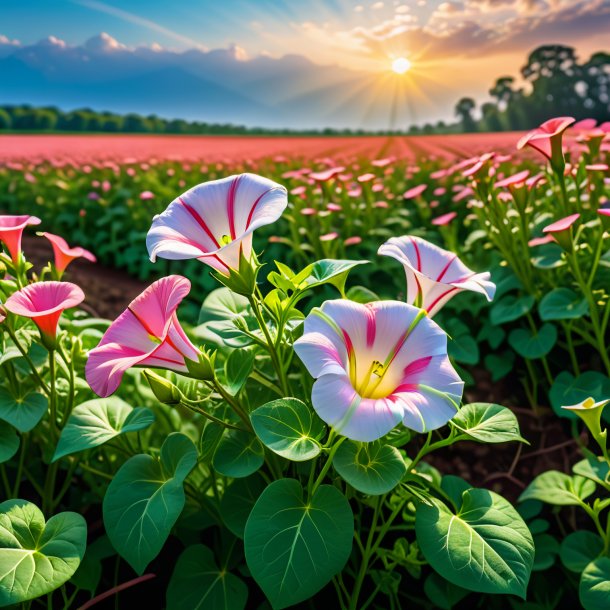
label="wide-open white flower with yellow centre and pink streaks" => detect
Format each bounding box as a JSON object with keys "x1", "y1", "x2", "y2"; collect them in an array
[{"x1": 294, "y1": 299, "x2": 464, "y2": 441}]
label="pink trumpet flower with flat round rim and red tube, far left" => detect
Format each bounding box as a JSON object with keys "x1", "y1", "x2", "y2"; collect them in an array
[{"x1": 4, "y1": 282, "x2": 85, "y2": 342}]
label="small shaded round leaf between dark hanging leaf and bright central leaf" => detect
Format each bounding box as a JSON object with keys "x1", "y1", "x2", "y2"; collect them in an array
[{"x1": 212, "y1": 429, "x2": 265, "y2": 478}]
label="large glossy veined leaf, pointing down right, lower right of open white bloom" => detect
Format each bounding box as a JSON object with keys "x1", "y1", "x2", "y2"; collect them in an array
[{"x1": 415, "y1": 489, "x2": 534, "y2": 598}]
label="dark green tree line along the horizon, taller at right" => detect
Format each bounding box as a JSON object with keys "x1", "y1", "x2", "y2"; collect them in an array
[{"x1": 0, "y1": 45, "x2": 610, "y2": 136}]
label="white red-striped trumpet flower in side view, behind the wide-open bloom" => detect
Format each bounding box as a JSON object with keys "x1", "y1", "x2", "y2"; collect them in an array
[{"x1": 378, "y1": 235, "x2": 496, "y2": 317}]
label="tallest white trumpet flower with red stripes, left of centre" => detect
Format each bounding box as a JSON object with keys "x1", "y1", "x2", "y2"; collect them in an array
[{"x1": 146, "y1": 174, "x2": 288, "y2": 275}]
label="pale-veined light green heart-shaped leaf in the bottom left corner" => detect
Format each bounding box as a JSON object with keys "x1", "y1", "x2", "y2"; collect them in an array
[{"x1": 0, "y1": 500, "x2": 87, "y2": 607}]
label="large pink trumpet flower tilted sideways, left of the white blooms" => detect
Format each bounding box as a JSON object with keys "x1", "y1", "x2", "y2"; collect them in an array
[{"x1": 85, "y1": 275, "x2": 199, "y2": 397}]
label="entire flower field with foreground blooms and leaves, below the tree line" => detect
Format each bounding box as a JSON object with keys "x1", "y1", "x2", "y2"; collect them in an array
[{"x1": 0, "y1": 117, "x2": 610, "y2": 610}]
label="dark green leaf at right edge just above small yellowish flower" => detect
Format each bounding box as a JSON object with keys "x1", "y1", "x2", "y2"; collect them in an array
[{"x1": 549, "y1": 371, "x2": 610, "y2": 419}]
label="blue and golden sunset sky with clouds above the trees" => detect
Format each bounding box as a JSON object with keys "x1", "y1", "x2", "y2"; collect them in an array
[{"x1": 0, "y1": 0, "x2": 610, "y2": 128}]
